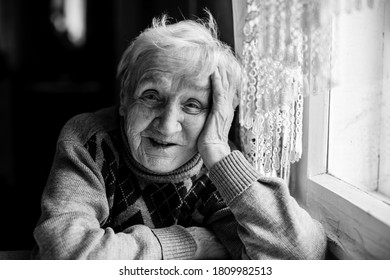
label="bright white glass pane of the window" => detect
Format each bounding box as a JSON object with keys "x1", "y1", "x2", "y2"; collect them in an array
[{"x1": 328, "y1": 1, "x2": 384, "y2": 191}]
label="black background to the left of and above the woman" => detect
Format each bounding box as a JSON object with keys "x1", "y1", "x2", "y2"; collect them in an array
[{"x1": 0, "y1": 0, "x2": 234, "y2": 251}]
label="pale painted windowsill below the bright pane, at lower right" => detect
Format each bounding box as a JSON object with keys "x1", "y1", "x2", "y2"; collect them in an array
[{"x1": 307, "y1": 174, "x2": 390, "y2": 259}]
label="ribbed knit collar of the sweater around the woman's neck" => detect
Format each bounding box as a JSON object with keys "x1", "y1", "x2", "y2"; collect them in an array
[{"x1": 119, "y1": 113, "x2": 203, "y2": 183}]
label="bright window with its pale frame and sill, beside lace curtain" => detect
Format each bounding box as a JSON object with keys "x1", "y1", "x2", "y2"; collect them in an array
[{"x1": 296, "y1": 1, "x2": 390, "y2": 259}]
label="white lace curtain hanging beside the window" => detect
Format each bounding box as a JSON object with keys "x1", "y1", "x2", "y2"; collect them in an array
[{"x1": 233, "y1": 0, "x2": 375, "y2": 180}]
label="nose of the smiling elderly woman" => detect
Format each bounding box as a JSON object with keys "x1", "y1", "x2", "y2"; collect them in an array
[{"x1": 154, "y1": 106, "x2": 182, "y2": 136}]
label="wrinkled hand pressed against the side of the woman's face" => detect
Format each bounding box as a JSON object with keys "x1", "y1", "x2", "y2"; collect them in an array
[{"x1": 198, "y1": 68, "x2": 236, "y2": 169}]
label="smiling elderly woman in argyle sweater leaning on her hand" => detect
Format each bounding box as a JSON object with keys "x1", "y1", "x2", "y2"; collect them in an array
[{"x1": 33, "y1": 15, "x2": 326, "y2": 259}]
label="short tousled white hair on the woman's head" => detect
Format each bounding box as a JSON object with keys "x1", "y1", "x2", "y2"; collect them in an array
[{"x1": 118, "y1": 11, "x2": 242, "y2": 101}]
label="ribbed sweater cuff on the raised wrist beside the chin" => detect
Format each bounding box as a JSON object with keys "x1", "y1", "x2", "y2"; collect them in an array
[{"x1": 209, "y1": 151, "x2": 263, "y2": 204}]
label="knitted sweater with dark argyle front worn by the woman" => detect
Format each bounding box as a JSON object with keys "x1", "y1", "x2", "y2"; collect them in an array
[{"x1": 33, "y1": 107, "x2": 326, "y2": 259}]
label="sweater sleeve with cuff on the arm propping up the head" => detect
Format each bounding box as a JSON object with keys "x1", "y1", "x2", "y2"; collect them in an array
[{"x1": 210, "y1": 151, "x2": 326, "y2": 259}]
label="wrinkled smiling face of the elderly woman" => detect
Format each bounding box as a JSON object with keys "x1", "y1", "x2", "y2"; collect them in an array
[{"x1": 120, "y1": 69, "x2": 211, "y2": 173}]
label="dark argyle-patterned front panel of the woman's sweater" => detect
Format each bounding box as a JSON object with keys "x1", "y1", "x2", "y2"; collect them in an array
[{"x1": 84, "y1": 124, "x2": 226, "y2": 232}]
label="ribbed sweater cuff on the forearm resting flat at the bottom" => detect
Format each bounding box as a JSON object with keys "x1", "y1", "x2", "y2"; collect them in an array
[{"x1": 151, "y1": 225, "x2": 197, "y2": 260}]
